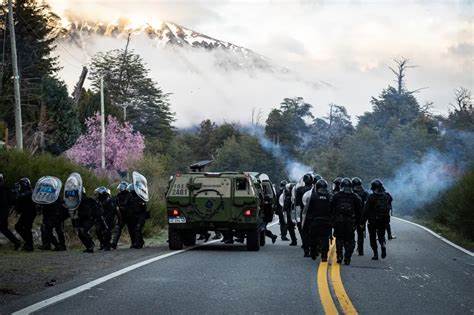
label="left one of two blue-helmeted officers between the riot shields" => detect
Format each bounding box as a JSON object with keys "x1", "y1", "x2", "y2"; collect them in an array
[{"x1": 94, "y1": 186, "x2": 120, "y2": 251}]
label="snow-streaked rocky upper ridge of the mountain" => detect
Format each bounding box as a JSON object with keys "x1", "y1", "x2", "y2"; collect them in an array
[{"x1": 63, "y1": 20, "x2": 274, "y2": 72}]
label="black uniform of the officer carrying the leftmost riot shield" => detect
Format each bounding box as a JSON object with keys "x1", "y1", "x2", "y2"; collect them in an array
[{"x1": 39, "y1": 198, "x2": 68, "y2": 250}]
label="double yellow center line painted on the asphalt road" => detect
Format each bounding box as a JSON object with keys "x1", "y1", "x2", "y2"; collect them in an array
[{"x1": 318, "y1": 240, "x2": 357, "y2": 315}]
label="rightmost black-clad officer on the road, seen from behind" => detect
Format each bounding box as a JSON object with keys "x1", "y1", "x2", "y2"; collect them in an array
[{"x1": 364, "y1": 179, "x2": 392, "y2": 260}]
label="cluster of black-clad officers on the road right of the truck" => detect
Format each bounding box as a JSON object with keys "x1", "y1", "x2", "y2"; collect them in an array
[{"x1": 277, "y1": 174, "x2": 393, "y2": 265}]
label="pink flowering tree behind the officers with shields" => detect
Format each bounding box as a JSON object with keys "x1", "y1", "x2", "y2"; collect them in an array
[{"x1": 65, "y1": 113, "x2": 145, "y2": 175}]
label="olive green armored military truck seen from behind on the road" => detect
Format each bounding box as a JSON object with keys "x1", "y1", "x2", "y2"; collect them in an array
[{"x1": 166, "y1": 164, "x2": 272, "y2": 251}]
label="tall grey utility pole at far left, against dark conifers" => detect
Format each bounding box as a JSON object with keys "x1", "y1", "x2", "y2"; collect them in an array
[{"x1": 8, "y1": 0, "x2": 23, "y2": 150}]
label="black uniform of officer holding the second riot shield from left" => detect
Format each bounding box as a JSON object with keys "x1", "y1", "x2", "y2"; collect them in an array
[{"x1": 73, "y1": 195, "x2": 106, "y2": 252}]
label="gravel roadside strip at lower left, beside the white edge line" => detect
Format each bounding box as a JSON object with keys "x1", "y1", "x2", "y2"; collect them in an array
[{"x1": 0, "y1": 237, "x2": 168, "y2": 308}]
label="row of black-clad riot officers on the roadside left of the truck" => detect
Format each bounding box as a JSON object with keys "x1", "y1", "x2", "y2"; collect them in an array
[{"x1": 0, "y1": 173, "x2": 149, "y2": 253}]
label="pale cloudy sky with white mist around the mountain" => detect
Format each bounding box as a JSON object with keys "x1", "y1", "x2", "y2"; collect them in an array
[{"x1": 48, "y1": 0, "x2": 474, "y2": 126}]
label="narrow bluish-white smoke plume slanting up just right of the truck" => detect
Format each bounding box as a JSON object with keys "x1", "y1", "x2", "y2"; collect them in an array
[{"x1": 247, "y1": 126, "x2": 313, "y2": 181}]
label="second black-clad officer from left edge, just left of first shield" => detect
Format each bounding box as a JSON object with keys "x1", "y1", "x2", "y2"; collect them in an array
[{"x1": 15, "y1": 178, "x2": 36, "y2": 252}]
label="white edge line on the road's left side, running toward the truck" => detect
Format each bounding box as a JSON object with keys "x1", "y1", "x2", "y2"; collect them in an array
[{"x1": 12, "y1": 221, "x2": 278, "y2": 315}]
